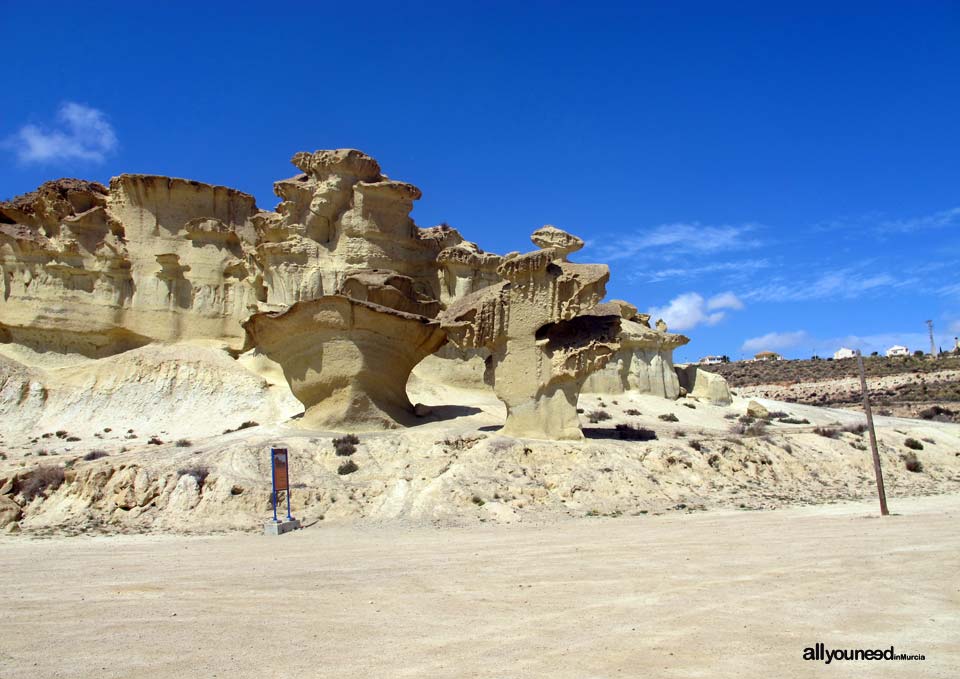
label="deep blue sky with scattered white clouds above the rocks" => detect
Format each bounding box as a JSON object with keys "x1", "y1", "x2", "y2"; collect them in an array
[{"x1": 0, "y1": 0, "x2": 960, "y2": 360}]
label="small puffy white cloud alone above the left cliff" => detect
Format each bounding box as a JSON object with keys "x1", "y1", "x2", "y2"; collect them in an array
[{"x1": 6, "y1": 101, "x2": 117, "y2": 163}]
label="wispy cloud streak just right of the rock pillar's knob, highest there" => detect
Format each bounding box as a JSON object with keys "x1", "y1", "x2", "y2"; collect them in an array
[{"x1": 595, "y1": 222, "x2": 760, "y2": 261}]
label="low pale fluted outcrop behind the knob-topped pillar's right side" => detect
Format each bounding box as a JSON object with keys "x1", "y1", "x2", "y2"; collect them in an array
[{"x1": 583, "y1": 300, "x2": 690, "y2": 399}]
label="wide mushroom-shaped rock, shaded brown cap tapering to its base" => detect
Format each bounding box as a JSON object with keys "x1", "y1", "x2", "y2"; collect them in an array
[{"x1": 243, "y1": 295, "x2": 446, "y2": 430}]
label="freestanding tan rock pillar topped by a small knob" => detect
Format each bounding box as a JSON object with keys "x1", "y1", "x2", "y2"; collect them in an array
[{"x1": 441, "y1": 227, "x2": 620, "y2": 439}]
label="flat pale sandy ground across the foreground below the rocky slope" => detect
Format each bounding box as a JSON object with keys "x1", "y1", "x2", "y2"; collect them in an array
[{"x1": 0, "y1": 494, "x2": 960, "y2": 679}]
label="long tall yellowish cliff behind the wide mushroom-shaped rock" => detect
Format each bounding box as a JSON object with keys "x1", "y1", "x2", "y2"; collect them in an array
[{"x1": 0, "y1": 149, "x2": 500, "y2": 357}]
